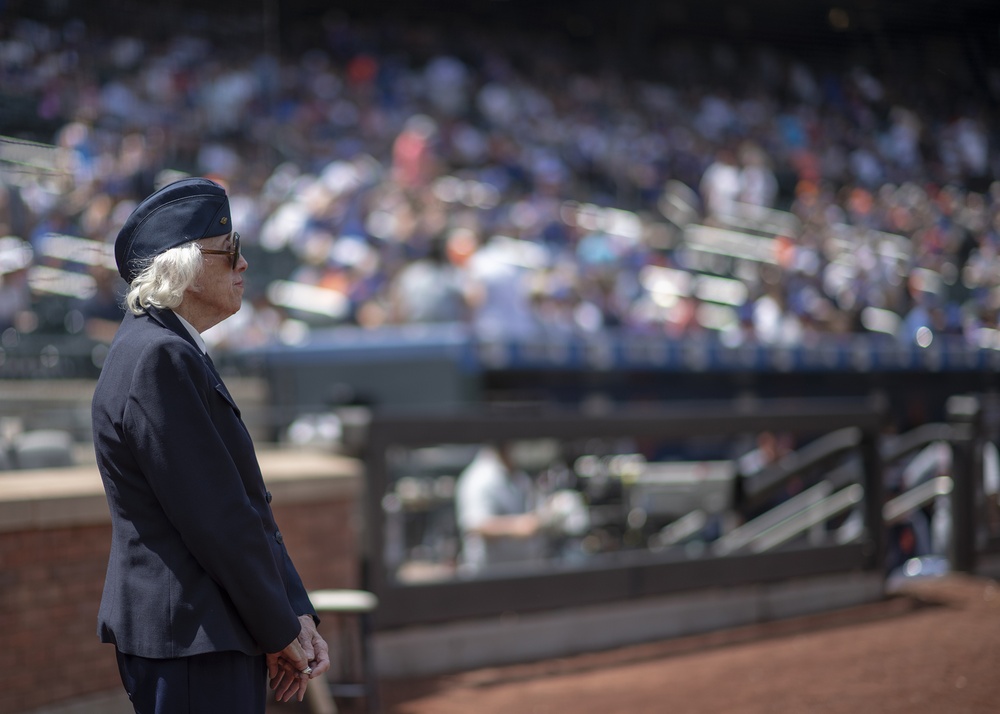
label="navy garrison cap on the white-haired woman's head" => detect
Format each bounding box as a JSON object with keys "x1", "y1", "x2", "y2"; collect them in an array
[{"x1": 115, "y1": 178, "x2": 232, "y2": 283}]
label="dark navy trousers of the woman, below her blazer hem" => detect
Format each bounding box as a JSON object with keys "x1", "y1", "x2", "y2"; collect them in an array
[{"x1": 117, "y1": 652, "x2": 267, "y2": 714}]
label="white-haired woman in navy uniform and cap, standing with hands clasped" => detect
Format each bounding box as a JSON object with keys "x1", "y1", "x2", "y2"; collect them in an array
[{"x1": 92, "y1": 178, "x2": 330, "y2": 714}]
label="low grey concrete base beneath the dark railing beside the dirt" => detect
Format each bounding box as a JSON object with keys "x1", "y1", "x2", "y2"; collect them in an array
[{"x1": 374, "y1": 572, "x2": 884, "y2": 678}]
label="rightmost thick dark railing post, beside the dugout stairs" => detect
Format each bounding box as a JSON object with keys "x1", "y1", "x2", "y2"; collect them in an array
[{"x1": 947, "y1": 396, "x2": 982, "y2": 573}]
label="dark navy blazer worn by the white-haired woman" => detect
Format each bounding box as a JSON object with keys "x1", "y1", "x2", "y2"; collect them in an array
[{"x1": 92, "y1": 309, "x2": 315, "y2": 658}]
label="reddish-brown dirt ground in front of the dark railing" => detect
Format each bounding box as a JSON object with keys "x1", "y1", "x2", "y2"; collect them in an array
[{"x1": 360, "y1": 575, "x2": 1000, "y2": 714}]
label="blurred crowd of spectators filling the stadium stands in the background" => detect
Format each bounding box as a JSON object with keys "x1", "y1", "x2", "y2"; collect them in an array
[{"x1": 0, "y1": 2, "x2": 1000, "y2": 349}]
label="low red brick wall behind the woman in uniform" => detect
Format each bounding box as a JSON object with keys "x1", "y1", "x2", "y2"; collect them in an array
[{"x1": 0, "y1": 450, "x2": 358, "y2": 714}]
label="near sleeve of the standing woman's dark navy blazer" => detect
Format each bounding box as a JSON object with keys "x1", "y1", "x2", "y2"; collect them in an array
[{"x1": 123, "y1": 341, "x2": 304, "y2": 652}]
